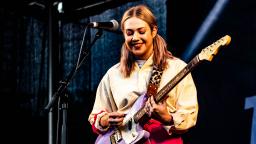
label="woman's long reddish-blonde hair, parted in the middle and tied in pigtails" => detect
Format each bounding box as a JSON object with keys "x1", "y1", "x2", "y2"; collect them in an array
[{"x1": 120, "y1": 5, "x2": 173, "y2": 77}]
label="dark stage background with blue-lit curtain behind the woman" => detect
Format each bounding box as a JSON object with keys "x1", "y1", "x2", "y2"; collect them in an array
[{"x1": 0, "y1": 0, "x2": 256, "y2": 144}]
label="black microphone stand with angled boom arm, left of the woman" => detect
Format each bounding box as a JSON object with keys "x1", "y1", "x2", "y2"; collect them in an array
[{"x1": 43, "y1": 27, "x2": 103, "y2": 144}]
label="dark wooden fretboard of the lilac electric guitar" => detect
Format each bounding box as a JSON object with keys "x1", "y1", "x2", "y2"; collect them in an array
[{"x1": 134, "y1": 55, "x2": 201, "y2": 123}]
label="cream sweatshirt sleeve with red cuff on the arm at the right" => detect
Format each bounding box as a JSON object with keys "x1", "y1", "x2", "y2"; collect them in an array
[{"x1": 164, "y1": 59, "x2": 198, "y2": 134}]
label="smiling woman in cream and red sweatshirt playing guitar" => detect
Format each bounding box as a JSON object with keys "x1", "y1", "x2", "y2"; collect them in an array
[{"x1": 89, "y1": 5, "x2": 198, "y2": 144}]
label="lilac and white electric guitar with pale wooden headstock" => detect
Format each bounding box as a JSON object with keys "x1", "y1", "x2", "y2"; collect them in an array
[{"x1": 95, "y1": 35, "x2": 231, "y2": 144}]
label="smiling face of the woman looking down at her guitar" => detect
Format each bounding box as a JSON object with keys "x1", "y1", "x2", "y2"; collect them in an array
[{"x1": 123, "y1": 17, "x2": 157, "y2": 60}]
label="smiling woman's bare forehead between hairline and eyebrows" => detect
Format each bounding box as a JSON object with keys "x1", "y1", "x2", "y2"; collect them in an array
[{"x1": 124, "y1": 17, "x2": 149, "y2": 29}]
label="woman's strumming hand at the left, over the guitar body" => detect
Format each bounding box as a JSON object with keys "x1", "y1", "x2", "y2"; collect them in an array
[{"x1": 100, "y1": 112, "x2": 125, "y2": 128}]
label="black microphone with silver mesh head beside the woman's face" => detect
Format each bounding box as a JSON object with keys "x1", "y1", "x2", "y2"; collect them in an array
[{"x1": 87, "y1": 19, "x2": 119, "y2": 31}]
